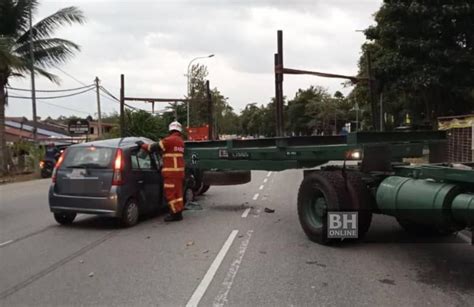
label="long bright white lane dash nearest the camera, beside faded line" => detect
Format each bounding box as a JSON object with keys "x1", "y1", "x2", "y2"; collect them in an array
[{"x1": 186, "y1": 229, "x2": 239, "y2": 307}]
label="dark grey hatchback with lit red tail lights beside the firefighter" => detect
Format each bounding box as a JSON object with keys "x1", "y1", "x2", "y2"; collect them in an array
[{"x1": 49, "y1": 137, "x2": 166, "y2": 227}]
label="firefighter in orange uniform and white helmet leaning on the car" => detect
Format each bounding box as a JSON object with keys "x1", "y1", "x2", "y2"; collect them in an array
[{"x1": 141, "y1": 121, "x2": 184, "y2": 222}]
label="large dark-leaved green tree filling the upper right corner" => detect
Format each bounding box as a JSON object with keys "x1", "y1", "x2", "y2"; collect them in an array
[{"x1": 352, "y1": 0, "x2": 474, "y2": 127}]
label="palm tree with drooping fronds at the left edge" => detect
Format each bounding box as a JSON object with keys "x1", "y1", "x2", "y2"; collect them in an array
[{"x1": 0, "y1": 0, "x2": 85, "y2": 175}]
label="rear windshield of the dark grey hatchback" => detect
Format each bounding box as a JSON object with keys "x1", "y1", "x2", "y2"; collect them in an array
[{"x1": 62, "y1": 146, "x2": 115, "y2": 169}]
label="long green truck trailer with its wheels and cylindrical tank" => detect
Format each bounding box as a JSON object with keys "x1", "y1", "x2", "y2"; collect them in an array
[{"x1": 185, "y1": 131, "x2": 474, "y2": 244}]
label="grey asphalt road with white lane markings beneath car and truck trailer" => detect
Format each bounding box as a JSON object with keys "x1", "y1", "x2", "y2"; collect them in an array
[{"x1": 0, "y1": 171, "x2": 474, "y2": 306}]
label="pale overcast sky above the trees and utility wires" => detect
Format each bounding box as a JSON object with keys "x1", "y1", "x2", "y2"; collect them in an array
[{"x1": 7, "y1": 0, "x2": 382, "y2": 118}]
